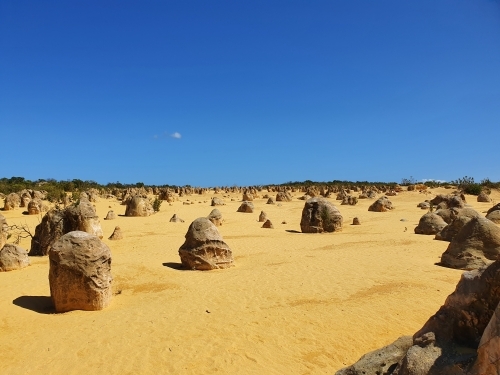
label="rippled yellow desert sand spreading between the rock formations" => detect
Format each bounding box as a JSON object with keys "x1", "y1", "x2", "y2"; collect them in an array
[{"x1": 0, "y1": 189, "x2": 500, "y2": 374}]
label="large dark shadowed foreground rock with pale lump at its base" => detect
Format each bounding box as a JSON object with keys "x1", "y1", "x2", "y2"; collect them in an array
[{"x1": 395, "y1": 261, "x2": 500, "y2": 375}]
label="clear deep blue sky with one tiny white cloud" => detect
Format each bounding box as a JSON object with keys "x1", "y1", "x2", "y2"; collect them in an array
[{"x1": 0, "y1": 0, "x2": 500, "y2": 186}]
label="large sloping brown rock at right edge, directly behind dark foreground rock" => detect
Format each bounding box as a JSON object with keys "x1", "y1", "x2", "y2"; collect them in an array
[{"x1": 441, "y1": 217, "x2": 500, "y2": 270}]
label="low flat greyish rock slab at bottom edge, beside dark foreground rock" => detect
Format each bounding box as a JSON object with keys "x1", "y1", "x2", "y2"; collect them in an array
[{"x1": 335, "y1": 336, "x2": 413, "y2": 375}]
